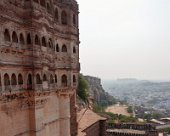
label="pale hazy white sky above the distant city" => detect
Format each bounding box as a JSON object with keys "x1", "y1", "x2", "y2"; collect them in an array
[{"x1": 77, "y1": 0, "x2": 170, "y2": 80}]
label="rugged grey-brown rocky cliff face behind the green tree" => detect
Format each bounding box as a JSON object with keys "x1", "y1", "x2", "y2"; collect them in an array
[{"x1": 84, "y1": 76, "x2": 113, "y2": 104}]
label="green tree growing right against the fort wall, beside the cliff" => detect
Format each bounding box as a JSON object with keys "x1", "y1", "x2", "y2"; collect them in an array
[{"x1": 78, "y1": 74, "x2": 89, "y2": 102}]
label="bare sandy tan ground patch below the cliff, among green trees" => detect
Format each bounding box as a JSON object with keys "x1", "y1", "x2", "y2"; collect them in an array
[{"x1": 106, "y1": 104, "x2": 130, "y2": 116}]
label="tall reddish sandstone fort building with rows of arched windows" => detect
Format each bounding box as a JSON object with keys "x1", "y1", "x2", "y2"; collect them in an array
[{"x1": 0, "y1": 0, "x2": 80, "y2": 136}]
